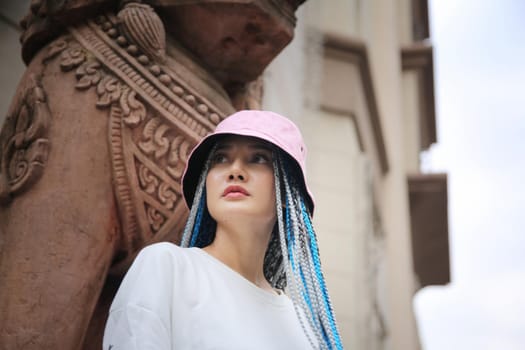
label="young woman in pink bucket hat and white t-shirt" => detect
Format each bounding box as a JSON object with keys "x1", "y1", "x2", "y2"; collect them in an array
[{"x1": 104, "y1": 111, "x2": 342, "y2": 350}]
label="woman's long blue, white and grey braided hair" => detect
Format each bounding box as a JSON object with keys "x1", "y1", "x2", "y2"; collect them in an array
[{"x1": 181, "y1": 148, "x2": 343, "y2": 350}]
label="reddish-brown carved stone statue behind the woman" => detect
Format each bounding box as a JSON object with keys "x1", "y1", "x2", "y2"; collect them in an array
[{"x1": 0, "y1": 0, "x2": 304, "y2": 349}]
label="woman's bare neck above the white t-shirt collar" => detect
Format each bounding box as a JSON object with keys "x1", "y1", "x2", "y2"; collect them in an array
[{"x1": 204, "y1": 223, "x2": 273, "y2": 290}]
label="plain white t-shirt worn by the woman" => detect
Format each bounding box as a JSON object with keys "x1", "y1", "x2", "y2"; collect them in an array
[{"x1": 103, "y1": 243, "x2": 312, "y2": 350}]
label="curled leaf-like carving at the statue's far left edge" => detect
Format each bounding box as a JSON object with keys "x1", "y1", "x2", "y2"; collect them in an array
[{"x1": 0, "y1": 75, "x2": 50, "y2": 204}]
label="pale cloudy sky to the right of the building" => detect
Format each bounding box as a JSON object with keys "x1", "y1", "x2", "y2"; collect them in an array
[{"x1": 414, "y1": 0, "x2": 525, "y2": 350}]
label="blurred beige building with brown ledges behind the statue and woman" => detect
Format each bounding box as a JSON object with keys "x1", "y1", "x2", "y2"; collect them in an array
[{"x1": 0, "y1": 0, "x2": 450, "y2": 350}]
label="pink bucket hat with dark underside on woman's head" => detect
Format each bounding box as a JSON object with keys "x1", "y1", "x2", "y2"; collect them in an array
[{"x1": 182, "y1": 110, "x2": 314, "y2": 214}]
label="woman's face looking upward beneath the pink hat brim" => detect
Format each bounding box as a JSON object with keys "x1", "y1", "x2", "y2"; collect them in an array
[{"x1": 206, "y1": 136, "x2": 276, "y2": 228}]
